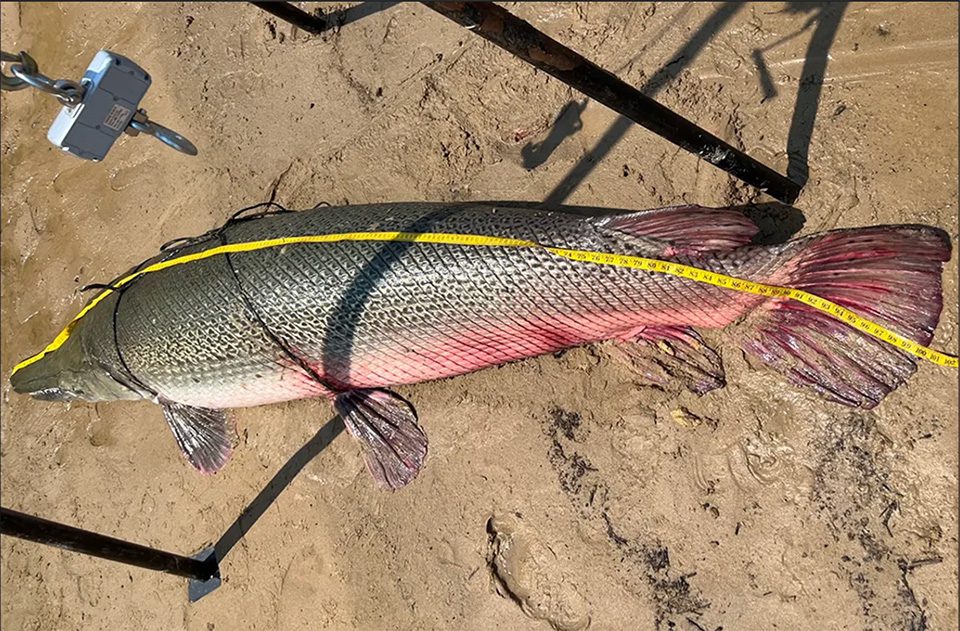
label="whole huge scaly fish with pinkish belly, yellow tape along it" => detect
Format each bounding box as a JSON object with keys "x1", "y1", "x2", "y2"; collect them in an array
[{"x1": 11, "y1": 203, "x2": 957, "y2": 489}]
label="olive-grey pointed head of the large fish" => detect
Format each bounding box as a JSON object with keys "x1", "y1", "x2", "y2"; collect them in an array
[{"x1": 10, "y1": 326, "x2": 141, "y2": 403}]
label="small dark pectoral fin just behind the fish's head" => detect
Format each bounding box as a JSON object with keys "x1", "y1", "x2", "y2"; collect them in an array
[{"x1": 160, "y1": 399, "x2": 233, "y2": 475}]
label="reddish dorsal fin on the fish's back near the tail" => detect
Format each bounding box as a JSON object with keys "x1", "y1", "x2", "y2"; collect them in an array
[{"x1": 592, "y1": 206, "x2": 758, "y2": 254}]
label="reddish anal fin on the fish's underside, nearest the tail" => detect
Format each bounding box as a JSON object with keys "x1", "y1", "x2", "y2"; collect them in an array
[{"x1": 619, "y1": 326, "x2": 726, "y2": 394}]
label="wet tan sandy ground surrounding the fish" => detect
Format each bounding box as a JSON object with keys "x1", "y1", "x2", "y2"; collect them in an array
[{"x1": 0, "y1": 2, "x2": 958, "y2": 631}]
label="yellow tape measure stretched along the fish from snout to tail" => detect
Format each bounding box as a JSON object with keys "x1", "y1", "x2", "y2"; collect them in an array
[{"x1": 13, "y1": 232, "x2": 960, "y2": 373}]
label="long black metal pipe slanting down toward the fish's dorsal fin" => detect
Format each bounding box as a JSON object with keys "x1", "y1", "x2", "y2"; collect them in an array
[{"x1": 423, "y1": 2, "x2": 802, "y2": 204}]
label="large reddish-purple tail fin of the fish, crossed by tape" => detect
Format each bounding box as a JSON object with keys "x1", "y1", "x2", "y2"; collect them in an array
[{"x1": 743, "y1": 226, "x2": 950, "y2": 408}]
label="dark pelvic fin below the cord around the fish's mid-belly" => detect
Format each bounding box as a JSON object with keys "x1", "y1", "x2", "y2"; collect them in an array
[{"x1": 333, "y1": 390, "x2": 427, "y2": 490}]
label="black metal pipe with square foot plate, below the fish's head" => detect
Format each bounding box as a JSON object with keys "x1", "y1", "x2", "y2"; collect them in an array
[{"x1": 0, "y1": 508, "x2": 220, "y2": 581}]
